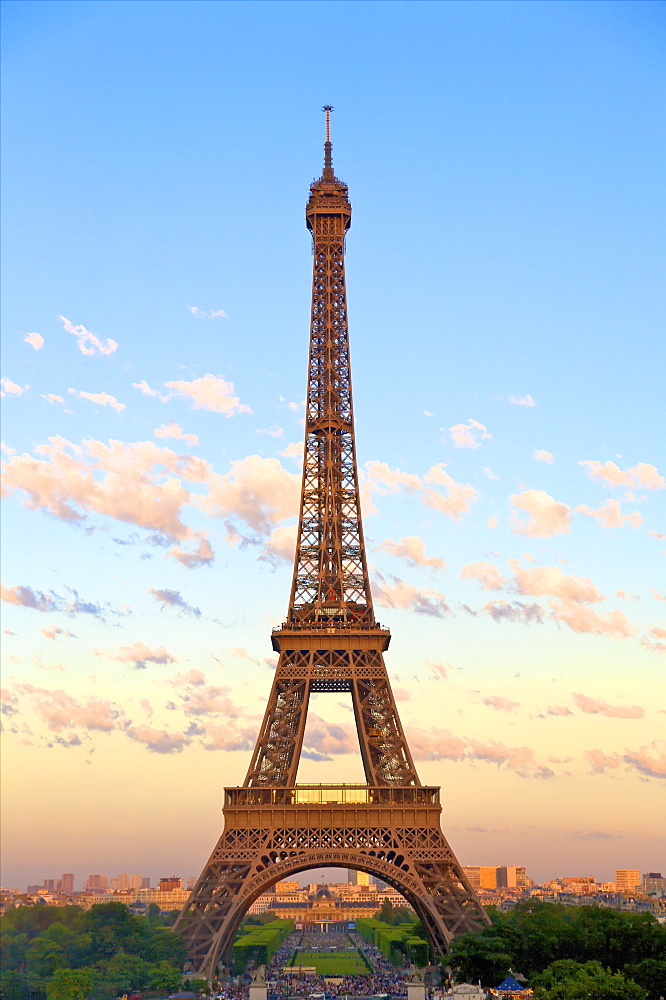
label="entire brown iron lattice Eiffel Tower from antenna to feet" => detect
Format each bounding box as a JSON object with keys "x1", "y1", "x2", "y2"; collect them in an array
[{"x1": 174, "y1": 106, "x2": 489, "y2": 979}]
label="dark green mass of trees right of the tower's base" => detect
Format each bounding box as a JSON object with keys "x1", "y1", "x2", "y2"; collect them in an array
[{"x1": 449, "y1": 900, "x2": 666, "y2": 1000}]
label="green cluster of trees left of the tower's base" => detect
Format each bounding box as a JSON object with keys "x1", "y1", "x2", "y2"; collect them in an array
[{"x1": 0, "y1": 903, "x2": 185, "y2": 1000}]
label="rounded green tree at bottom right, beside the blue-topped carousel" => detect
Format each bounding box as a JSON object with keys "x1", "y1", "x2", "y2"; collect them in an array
[{"x1": 534, "y1": 959, "x2": 647, "y2": 1000}]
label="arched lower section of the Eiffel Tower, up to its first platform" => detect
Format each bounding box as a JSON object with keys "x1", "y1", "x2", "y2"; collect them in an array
[{"x1": 174, "y1": 785, "x2": 490, "y2": 980}]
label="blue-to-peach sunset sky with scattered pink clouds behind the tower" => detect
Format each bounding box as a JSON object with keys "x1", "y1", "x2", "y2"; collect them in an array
[{"x1": 2, "y1": 0, "x2": 666, "y2": 884}]
